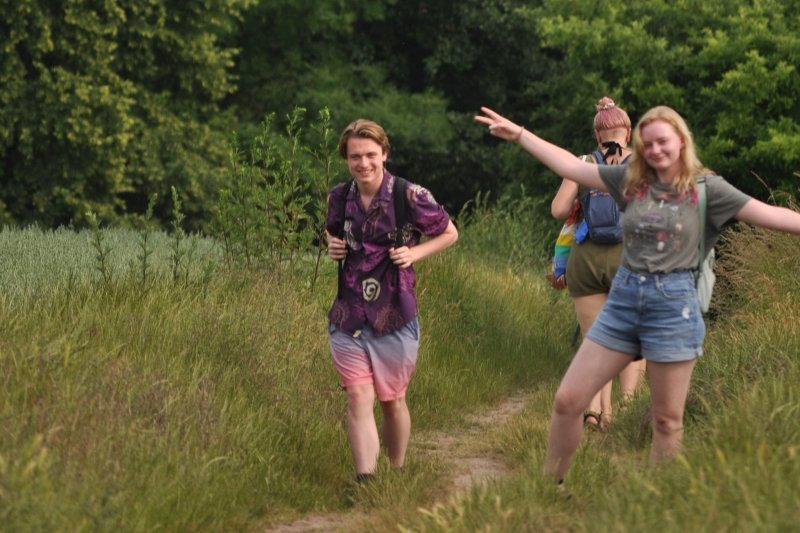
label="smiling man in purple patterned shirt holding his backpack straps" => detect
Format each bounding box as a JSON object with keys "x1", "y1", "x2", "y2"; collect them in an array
[{"x1": 325, "y1": 119, "x2": 458, "y2": 482}]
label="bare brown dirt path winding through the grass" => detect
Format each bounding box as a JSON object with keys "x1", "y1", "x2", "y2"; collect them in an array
[{"x1": 267, "y1": 392, "x2": 531, "y2": 533}]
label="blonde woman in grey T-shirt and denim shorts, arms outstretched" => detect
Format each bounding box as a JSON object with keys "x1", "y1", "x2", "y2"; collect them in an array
[{"x1": 475, "y1": 106, "x2": 800, "y2": 484}]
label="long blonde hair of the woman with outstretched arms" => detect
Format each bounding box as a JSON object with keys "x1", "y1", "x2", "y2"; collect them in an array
[{"x1": 622, "y1": 106, "x2": 711, "y2": 195}]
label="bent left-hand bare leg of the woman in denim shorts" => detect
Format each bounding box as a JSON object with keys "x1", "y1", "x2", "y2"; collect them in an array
[{"x1": 545, "y1": 339, "x2": 631, "y2": 480}]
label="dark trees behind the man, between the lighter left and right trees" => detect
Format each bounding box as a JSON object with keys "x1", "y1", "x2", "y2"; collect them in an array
[{"x1": 229, "y1": 0, "x2": 560, "y2": 215}]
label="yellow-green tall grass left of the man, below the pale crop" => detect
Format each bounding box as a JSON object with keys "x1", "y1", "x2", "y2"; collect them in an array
[{"x1": 0, "y1": 266, "x2": 346, "y2": 530}]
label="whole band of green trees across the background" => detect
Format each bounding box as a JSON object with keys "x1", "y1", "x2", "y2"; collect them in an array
[{"x1": 0, "y1": 0, "x2": 800, "y2": 229}]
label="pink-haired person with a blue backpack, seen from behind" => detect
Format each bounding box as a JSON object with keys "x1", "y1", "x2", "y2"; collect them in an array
[{"x1": 550, "y1": 96, "x2": 645, "y2": 430}]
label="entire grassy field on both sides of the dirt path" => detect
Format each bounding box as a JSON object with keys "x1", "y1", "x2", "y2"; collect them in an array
[{"x1": 0, "y1": 212, "x2": 800, "y2": 532}]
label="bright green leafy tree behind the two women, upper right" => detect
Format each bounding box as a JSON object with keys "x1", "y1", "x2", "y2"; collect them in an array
[{"x1": 520, "y1": 0, "x2": 800, "y2": 196}]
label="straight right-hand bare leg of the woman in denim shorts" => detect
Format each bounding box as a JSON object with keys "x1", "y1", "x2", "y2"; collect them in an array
[{"x1": 647, "y1": 359, "x2": 696, "y2": 465}]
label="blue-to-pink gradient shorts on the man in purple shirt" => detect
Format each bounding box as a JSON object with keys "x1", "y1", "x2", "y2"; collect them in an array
[{"x1": 328, "y1": 319, "x2": 419, "y2": 402}]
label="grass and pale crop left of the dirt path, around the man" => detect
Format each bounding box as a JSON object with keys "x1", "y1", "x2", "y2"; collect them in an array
[{"x1": 0, "y1": 209, "x2": 568, "y2": 531}]
